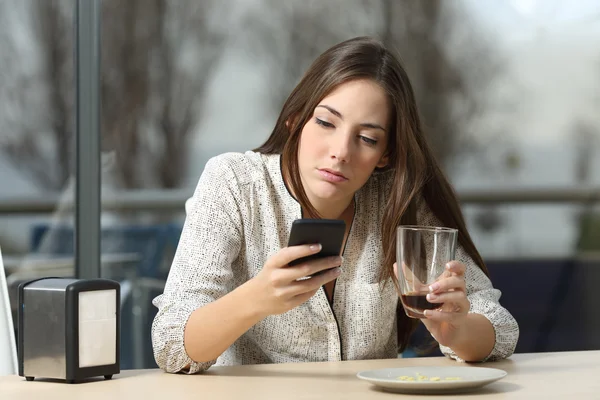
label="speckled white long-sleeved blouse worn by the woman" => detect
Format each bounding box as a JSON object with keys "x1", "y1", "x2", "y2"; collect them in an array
[{"x1": 152, "y1": 152, "x2": 519, "y2": 373}]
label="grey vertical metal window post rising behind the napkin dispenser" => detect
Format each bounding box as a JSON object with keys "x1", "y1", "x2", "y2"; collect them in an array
[{"x1": 74, "y1": 0, "x2": 101, "y2": 279}]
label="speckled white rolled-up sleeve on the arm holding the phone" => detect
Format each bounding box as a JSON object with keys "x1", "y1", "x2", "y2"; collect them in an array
[{"x1": 152, "y1": 157, "x2": 243, "y2": 373}]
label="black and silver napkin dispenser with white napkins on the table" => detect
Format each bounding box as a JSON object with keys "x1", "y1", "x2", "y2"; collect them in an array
[{"x1": 18, "y1": 278, "x2": 121, "y2": 383}]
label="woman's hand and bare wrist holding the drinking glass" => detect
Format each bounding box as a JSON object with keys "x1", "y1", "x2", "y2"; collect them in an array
[{"x1": 422, "y1": 261, "x2": 471, "y2": 347}]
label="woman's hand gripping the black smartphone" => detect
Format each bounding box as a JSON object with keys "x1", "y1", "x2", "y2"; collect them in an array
[{"x1": 249, "y1": 244, "x2": 342, "y2": 317}]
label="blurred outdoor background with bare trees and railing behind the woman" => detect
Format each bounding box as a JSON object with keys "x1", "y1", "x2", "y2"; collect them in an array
[{"x1": 0, "y1": 0, "x2": 600, "y2": 369}]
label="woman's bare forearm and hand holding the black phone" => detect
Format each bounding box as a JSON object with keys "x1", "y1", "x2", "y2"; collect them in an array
[{"x1": 184, "y1": 245, "x2": 341, "y2": 362}]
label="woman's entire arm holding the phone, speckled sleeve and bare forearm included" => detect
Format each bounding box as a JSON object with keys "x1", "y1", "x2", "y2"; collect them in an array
[{"x1": 152, "y1": 155, "x2": 341, "y2": 373}]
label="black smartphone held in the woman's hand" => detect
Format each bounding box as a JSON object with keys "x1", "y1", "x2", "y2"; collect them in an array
[{"x1": 288, "y1": 218, "x2": 346, "y2": 265}]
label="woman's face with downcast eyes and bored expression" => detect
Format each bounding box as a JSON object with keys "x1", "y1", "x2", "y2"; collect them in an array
[{"x1": 298, "y1": 79, "x2": 390, "y2": 205}]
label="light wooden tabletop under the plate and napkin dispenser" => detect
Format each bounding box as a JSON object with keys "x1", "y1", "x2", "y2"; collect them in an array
[{"x1": 0, "y1": 351, "x2": 600, "y2": 400}]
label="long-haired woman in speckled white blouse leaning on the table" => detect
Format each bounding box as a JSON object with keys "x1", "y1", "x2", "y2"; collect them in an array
[{"x1": 152, "y1": 38, "x2": 518, "y2": 373}]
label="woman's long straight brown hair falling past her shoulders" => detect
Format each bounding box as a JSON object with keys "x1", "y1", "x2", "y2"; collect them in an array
[{"x1": 255, "y1": 37, "x2": 488, "y2": 351}]
